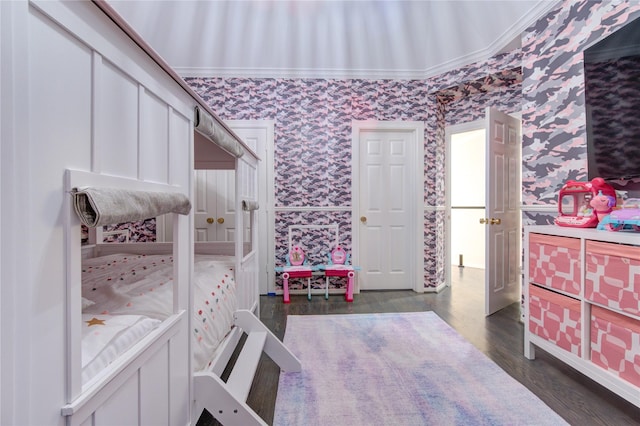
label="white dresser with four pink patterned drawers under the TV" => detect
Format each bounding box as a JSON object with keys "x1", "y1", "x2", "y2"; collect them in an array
[{"x1": 523, "y1": 225, "x2": 640, "y2": 407}]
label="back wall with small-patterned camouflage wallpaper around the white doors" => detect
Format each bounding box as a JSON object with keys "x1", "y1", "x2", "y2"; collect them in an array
[{"x1": 186, "y1": 52, "x2": 520, "y2": 287}]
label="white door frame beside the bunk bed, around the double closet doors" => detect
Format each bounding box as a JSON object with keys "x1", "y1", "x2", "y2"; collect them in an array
[{"x1": 224, "y1": 120, "x2": 276, "y2": 294}]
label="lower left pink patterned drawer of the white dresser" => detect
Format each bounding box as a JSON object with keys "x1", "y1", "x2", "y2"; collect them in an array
[{"x1": 529, "y1": 284, "x2": 582, "y2": 356}]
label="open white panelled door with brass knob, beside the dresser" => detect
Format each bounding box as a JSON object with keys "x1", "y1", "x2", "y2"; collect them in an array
[{"x1": 482, "y1": 108, "x2": 521, "y2": 315}]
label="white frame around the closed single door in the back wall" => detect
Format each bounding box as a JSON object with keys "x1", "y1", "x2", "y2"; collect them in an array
[{"x1": 351, "y1": 120, "x2": 425, "y2": 293}]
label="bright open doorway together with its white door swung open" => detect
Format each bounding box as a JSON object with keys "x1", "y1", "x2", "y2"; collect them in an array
[{"x1": 445, "y1": 107, "x2": 522, "y2": 315}]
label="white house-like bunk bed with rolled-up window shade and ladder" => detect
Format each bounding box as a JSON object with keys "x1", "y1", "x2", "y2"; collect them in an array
[{"x1": 0, "y1": 0, "x2": 300, "y2": 426}]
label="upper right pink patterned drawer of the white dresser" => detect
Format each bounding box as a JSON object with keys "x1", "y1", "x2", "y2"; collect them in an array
[{"x1": 584, "y1": 241, "x2": 640, "y2": 315}]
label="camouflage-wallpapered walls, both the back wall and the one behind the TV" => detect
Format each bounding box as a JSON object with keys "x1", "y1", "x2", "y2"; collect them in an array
[{"x1": 186, "y1": 0, "x2": 640, "y2": 288}]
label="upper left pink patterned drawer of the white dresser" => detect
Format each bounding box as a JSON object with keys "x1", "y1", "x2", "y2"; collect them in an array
[{"x1": 529, "y1": 233, "x2": 582, "y2": 296}]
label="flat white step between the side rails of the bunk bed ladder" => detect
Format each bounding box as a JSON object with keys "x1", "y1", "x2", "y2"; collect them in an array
[{"x1": 227, "y1": 331, "x2": 267, "y2": 401}]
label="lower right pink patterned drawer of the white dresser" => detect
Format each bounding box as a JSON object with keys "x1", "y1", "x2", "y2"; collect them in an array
[{"x1": 591, "y1": 306, "x2": 640, "y2": 386}]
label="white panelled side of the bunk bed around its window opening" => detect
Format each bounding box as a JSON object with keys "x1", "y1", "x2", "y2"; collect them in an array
[{"x1": 0, "y1": 1, "x2": 225, "y2": 426}]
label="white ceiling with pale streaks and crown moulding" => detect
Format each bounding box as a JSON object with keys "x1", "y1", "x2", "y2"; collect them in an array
[{"x1": 109, "y1": 0, "x2": 555, "y2": 79}]
